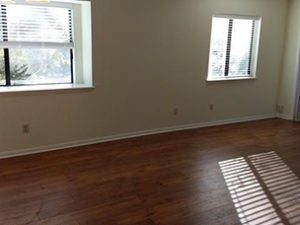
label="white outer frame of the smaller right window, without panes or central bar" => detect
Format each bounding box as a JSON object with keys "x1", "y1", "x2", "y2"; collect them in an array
[{"x1": 207, "y1": 14, "x2": 262, "y2": 81}]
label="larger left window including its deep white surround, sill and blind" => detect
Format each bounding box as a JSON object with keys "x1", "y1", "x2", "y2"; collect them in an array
[{"x1": 0, "y1": 0, "x2": 93, "y2": 94}]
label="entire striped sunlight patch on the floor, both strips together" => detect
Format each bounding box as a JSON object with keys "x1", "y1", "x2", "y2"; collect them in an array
[{"x1": 219, "y1": 152, "x2": 300, "y2": 225}]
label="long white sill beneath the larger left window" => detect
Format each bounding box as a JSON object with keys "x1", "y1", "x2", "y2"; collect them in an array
[{"x1": 0, "y1": 84, "x2": 95, "y2": 94}]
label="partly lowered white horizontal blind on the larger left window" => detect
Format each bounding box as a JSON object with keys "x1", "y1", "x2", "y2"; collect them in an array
[{"x1": 0, "y1": 4, "x2": 74, "y2": 48}]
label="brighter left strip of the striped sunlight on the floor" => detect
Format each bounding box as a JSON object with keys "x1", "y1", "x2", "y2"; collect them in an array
[{"x1": 219, "y1": 158, "x2": 283, "y2": 225}]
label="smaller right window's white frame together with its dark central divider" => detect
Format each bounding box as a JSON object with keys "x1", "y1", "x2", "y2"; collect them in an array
[{"x1": 206, "y1": 14, "x2": 262, "y2": 81}]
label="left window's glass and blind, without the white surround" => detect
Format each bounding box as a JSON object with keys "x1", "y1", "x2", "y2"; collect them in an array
[{"x1": 0, "y1": 4, "x2": 74, "y2": 86}]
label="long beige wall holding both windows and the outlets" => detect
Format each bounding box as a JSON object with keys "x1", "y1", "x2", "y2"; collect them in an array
[{"x1": 0, "y1": 0, "x2": 288, "y2": 152}]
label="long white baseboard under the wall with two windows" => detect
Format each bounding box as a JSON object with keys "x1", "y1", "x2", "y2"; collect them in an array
[{"x1": 0, "y1": 114, "x2": 276, "y2": 159}]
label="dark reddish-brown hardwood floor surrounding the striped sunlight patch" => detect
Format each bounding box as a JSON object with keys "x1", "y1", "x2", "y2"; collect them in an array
[{"x1": 0, "y1": 119, "x2": 300, "y2": 225}]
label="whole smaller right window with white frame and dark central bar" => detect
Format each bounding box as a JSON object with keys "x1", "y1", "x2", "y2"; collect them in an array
[{"x1": 208, "y1": 16, "x2": 260, "y2": 80}]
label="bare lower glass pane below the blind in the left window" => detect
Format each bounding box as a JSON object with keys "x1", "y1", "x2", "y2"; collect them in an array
[{"x1": 10, "y1": 48, "x2": 72, "y2": 85}]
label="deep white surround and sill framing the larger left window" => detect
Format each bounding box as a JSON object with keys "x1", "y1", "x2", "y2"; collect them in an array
[{"x1": 0, "y1": 0, "x2": 94, "y2": 94}]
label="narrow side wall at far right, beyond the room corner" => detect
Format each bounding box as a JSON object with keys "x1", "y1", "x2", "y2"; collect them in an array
[{"x1": 278, "y1": 0, "x2": 300, "y2": 119}]
